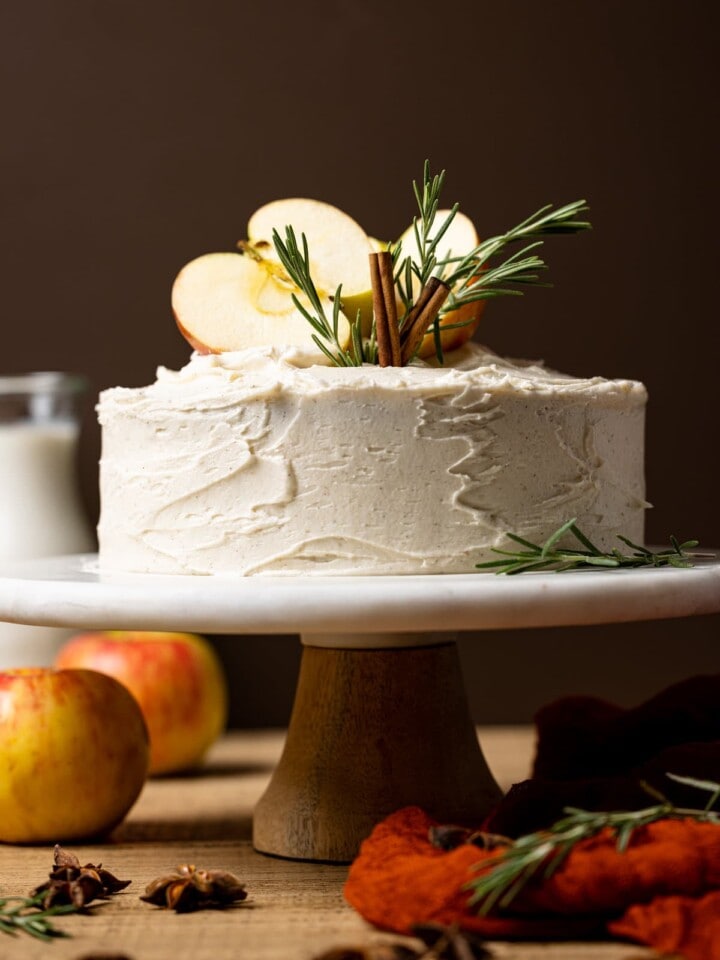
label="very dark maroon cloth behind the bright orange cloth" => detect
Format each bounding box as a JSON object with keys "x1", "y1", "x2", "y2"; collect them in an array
[{"x1": 486, "y1": 674, "x2": 720, "y2": 837}]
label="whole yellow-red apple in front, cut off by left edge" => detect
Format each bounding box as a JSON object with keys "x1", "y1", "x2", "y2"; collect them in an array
[{"x1": 0, "y1": 667, "x2": 149, "y2": 843}]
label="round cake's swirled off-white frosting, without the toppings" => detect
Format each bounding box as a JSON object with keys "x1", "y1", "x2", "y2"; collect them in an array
[{"x1": 98, "y1": 344, "x2": 647, "y2": 575}]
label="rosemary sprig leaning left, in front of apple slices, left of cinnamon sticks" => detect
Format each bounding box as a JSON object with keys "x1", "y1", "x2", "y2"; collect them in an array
[{"x1": 273, "y1": 226, "x2": 364, "y2": 367}]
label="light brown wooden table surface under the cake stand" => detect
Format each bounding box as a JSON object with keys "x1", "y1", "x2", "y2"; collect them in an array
[{"x1": 0, "y1": 727, "x2": 655, "y2": 960}]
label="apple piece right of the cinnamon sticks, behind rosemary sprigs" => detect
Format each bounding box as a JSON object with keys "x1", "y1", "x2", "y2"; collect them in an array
[{"x1": 398, "y1": 210, "x2": 485, "y2": 358}]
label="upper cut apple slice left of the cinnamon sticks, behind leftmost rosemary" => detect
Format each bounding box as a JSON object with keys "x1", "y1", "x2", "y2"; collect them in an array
[{"x1": 248, "y1": 197, "x2": 374, "y2": 331}]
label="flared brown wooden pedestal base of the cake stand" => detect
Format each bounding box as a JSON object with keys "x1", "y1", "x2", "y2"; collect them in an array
[{"x1": 253, "y1": 635, "x2": 500, "y2": 863}]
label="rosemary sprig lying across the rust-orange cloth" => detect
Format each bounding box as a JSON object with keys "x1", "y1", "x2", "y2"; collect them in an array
[{"x1": 466, "y1": 773, "x2": 720, "y2": 914}]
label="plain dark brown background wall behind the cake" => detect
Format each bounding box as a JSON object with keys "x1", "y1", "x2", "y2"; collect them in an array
[{"x1": 0, "y1": 0, "x2": 720, "y2": 724}]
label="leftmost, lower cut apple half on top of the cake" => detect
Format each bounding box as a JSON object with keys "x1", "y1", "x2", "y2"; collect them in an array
[{"x1": 172, "y1": 253, "x2": 350, "y2": 357}]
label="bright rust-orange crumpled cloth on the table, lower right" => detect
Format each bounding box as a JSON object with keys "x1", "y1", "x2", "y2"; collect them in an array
[{"x1": 345, "y1": 807, "x2": 720, "y2": 960}]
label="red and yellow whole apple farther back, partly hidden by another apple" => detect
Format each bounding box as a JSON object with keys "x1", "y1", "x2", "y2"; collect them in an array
[{"x1": 55, "y1": 630, "x2": 228, "y2": 773}]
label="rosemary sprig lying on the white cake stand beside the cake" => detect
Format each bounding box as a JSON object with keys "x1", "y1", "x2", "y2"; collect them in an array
[{"x1": 475, "y1": 518, "x2": 712, "y2": 575}]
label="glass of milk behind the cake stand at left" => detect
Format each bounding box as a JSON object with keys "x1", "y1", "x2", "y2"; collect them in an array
[{"x1": 0, "y1": 373, "x2": 94, "y2": 669}]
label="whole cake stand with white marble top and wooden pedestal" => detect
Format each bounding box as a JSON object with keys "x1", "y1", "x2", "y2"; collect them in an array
[{"x1": 0, "y1": 552, "x2": 720, "y2": 862}]
